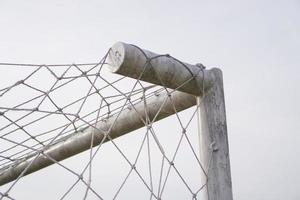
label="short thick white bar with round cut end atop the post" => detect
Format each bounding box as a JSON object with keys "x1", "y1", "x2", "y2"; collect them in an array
[{"x1": 108, "y1": 42, "x2": 214, "y2": 96}]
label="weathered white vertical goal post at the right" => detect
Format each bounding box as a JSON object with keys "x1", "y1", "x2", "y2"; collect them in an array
[{"x1": 197, "y1": 68, "x2": 233, "y2": 200}]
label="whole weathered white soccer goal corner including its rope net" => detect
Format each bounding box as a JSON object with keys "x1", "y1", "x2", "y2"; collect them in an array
[{"x1": 0, "y1": 42, "x2": 232, "y2": 200}]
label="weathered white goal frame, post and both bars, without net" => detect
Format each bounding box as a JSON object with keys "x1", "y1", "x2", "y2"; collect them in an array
[{"x1": 0, "y1": 42, "x2": 233, "y2": 200}]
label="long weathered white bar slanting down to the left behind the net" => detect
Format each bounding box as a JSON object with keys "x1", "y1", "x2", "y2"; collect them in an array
[{"x1": 0, "y1": 91, "x2": 196, "y2": 185}]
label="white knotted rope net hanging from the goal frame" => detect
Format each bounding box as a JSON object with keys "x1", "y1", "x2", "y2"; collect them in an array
[{"x1": 0, "y1": 49, "x2": 207, "y2": 200}]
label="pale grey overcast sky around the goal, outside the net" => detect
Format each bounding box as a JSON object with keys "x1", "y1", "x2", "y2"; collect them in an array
[{"x1": 0, "y1": 0, "x2": 300, "y2": 200}]
